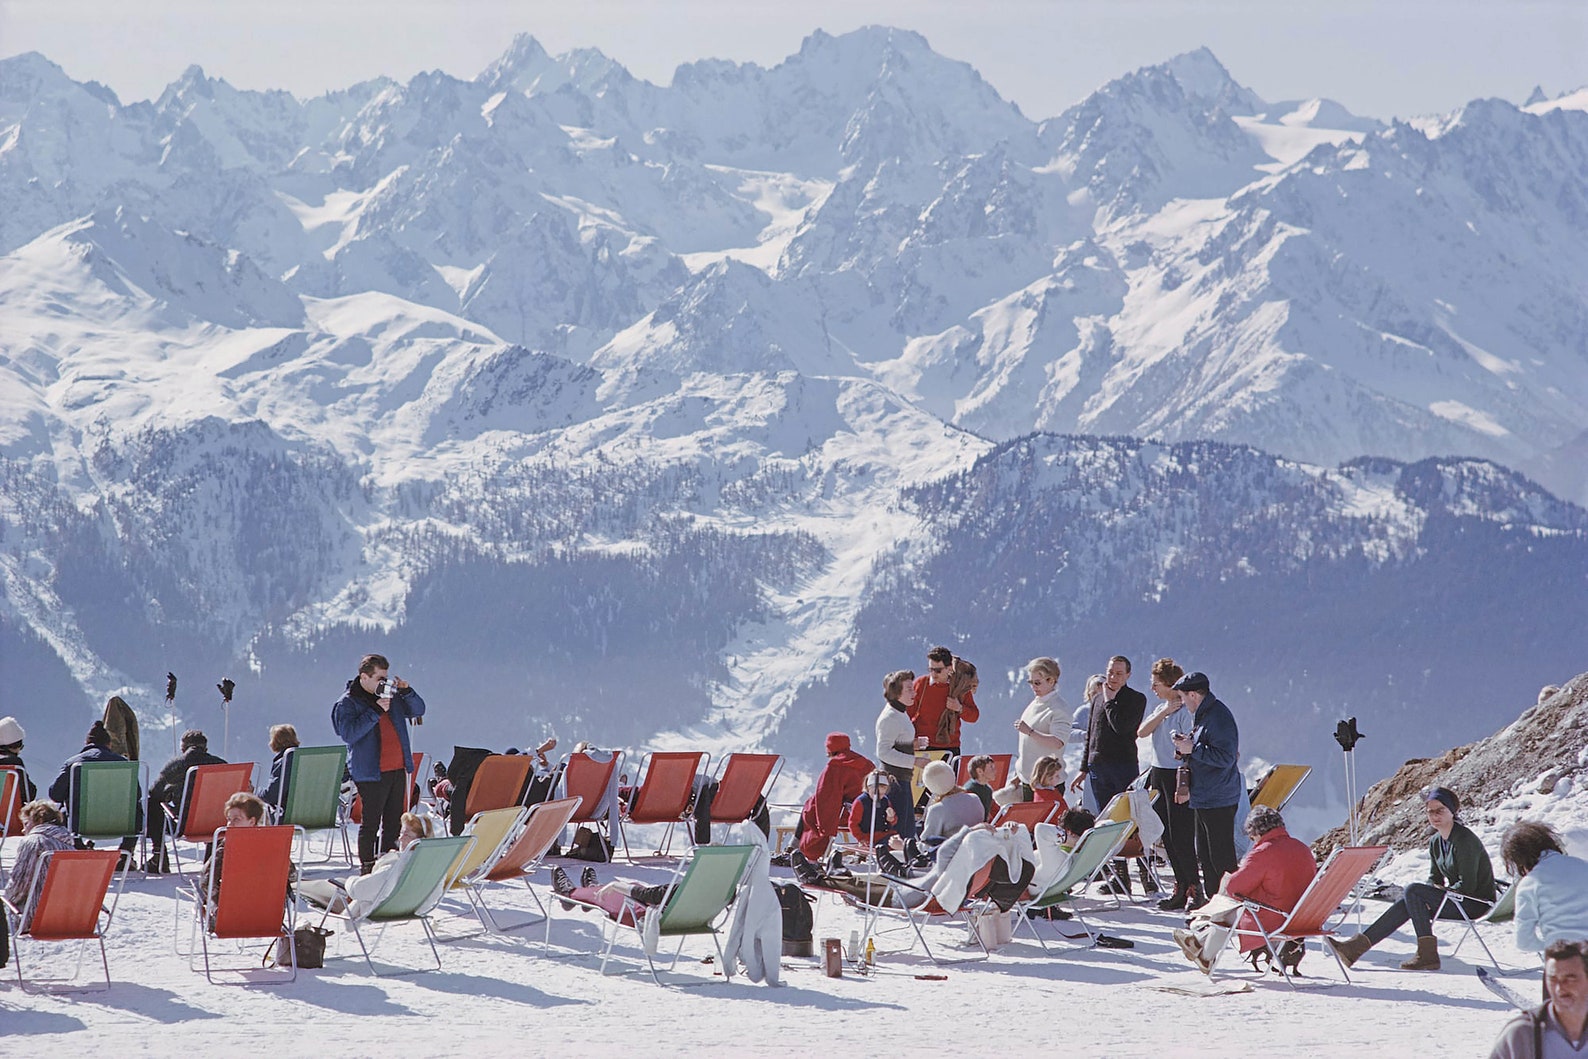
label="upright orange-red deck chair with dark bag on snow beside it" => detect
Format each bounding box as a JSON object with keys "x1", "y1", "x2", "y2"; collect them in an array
[{"x1": 189, "y1": 824, "x2": 297, "y2": 983}]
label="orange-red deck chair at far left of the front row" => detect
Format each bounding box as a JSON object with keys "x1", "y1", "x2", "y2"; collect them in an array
[{"x1": 5, "y1": 849, "x2": 127, "y2": 992}]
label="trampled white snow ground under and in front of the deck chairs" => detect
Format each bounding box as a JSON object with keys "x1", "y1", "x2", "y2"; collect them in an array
[{"x1": 0, "y1": 791, "x2": 1588, "y2": 1057}]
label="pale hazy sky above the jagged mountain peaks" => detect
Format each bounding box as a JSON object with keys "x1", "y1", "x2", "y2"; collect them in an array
[{"x1": 0, "y1": 0, "x2": 1588, "y2": 119}]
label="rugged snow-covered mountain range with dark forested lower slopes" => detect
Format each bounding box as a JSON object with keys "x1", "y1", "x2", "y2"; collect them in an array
[{"x1": 0, "y1": 27, "x2": 1588, "y2": 793}]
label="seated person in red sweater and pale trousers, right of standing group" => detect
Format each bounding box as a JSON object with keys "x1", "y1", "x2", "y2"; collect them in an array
[{"x1": 1175, "y1": 805, "x2": 1318, "y2": 973}]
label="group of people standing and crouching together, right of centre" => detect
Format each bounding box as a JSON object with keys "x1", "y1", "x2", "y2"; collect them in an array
[{"x1": 791, "y1": 646, "x2": 1245, "y2": 911}]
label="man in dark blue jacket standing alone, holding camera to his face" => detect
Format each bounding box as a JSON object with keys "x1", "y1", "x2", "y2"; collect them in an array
[{"x1": 330, "y1": 654, "x2": 424, "y2": 875}]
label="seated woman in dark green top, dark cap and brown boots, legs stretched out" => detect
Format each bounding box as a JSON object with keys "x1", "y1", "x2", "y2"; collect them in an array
[{"x1": 1324, "y1": 788, "x2": 1494, "y2": 970}]
